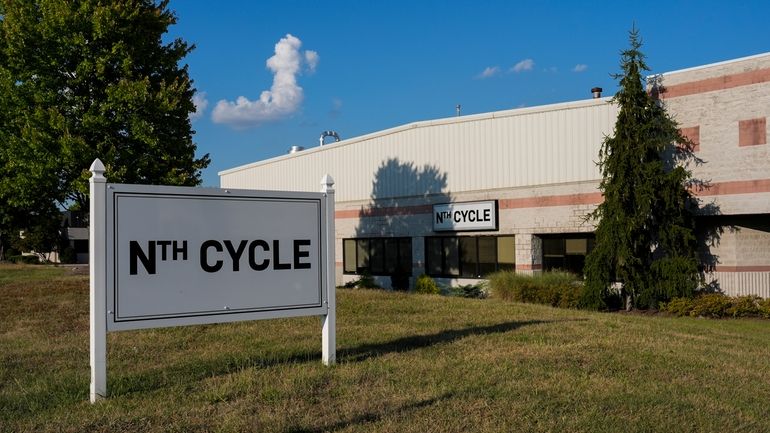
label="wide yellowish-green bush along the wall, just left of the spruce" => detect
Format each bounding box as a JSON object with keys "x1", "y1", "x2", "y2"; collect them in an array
[{"x1": 488, "y1": 271, "x2": 583, "y2": 308}]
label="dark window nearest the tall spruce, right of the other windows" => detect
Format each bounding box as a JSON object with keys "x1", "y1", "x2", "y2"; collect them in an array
[{"x1": 541, "y1": 234, "x2": 595, "y2": 275}]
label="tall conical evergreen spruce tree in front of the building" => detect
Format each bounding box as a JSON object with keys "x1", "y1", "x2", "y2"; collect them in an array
[{"x1": 582, "y1": 28, "x2": 702, "y2": 309}]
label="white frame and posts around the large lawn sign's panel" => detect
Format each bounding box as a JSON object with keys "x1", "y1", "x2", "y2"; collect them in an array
[{"x1": 89, "y1": 159, "x2": 336, "y2": 403}]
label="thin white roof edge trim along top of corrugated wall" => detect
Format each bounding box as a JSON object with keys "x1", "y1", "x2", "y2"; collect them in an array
[{"x1": 217, "y1": 96, "x2": 612, "y2": 177}]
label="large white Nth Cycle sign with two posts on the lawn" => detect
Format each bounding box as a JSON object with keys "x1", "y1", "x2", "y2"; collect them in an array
[{"x1": 91, "y1": 160, "x2": 336, "y2": 402}]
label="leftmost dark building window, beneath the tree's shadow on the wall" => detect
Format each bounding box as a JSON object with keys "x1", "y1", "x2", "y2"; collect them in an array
[{"x1": 342, "y1": 238, "x2": 412, "y2": 275}]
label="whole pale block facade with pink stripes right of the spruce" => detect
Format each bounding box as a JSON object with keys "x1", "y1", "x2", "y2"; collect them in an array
[{"x1": 660, "y1": 54, "x2": 770, "y2": 297}]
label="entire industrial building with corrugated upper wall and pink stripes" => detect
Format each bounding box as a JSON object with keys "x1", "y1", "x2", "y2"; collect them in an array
[{"x1": 219, "y1": 53, "x2": 770, "y2": 297}]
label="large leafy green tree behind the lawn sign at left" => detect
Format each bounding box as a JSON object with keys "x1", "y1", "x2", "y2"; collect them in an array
[{"x1": 0, "y1": 0, "x2": 209, "y2": 256}]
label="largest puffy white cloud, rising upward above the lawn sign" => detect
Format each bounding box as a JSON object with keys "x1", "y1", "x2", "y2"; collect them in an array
[{"x1": 211, "y1": 34, "x2": 319, "y2": 128}]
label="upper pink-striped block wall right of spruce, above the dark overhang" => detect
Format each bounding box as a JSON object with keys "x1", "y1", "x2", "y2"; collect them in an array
[{"x1": 660, "y1": 55, "x2": 770, "y2": 214}]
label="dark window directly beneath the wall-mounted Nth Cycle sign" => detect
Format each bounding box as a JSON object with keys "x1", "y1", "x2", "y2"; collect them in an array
[{"x1": 425, "y1": 236, "x2": 516, "y2": 278}]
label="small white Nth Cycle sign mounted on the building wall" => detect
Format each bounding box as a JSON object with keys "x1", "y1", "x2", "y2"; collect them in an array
[{"x1": 433, "y1": 200, "x2": 497, "y2": 232}]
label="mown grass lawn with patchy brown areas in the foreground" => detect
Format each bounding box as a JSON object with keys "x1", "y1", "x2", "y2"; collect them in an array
[{"x1": 0, "y1": 266, "x2": 770, "y2": 433}]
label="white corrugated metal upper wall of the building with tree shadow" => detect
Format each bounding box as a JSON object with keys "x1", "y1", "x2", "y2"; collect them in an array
[{"x1": 220, "y1": 98, "x2": 617, "y2": 201}]
